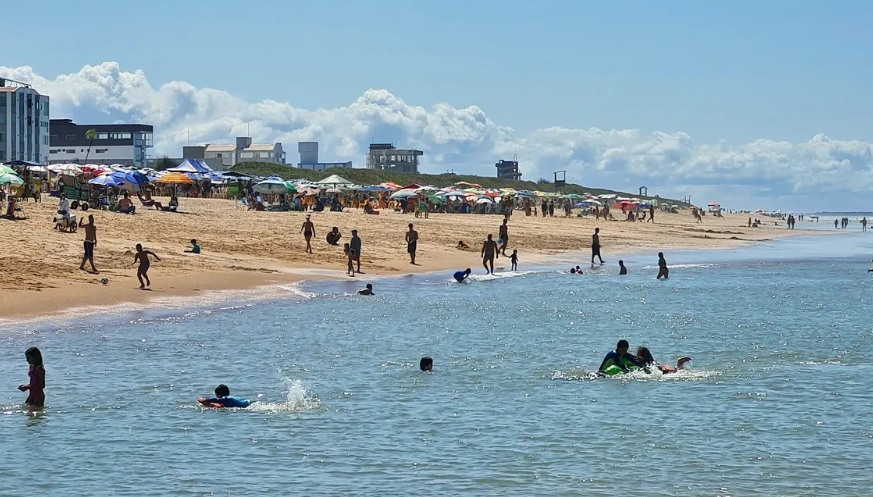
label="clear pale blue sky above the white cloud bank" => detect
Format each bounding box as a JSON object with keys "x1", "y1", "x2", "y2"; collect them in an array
[{"x1": 0, "y1": 0, "x2": 873, "y2": 209}]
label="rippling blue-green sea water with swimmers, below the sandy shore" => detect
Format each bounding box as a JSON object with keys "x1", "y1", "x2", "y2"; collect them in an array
[{"x1": 0, "y1": 234, "x2": 873, "y2": 496}]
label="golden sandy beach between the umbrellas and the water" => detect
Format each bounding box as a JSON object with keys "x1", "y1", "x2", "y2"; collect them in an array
[{"x1": 0, "y1": 196, "x2": 821, "y2": 319}]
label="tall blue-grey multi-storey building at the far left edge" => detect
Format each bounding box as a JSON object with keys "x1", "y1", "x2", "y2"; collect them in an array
[{"x1": 0, "y1": 78, "x2": 49, "y2": 164}]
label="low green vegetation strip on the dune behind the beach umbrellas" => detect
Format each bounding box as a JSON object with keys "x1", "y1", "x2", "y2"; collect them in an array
[{"x1": 231, "y1": 162, "x2": 685, "y2": 205}]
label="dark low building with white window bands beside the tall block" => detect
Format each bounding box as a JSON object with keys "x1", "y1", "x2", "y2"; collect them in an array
[{"x1": 49, "y1": 119, "x2": 154, "y2": 167}]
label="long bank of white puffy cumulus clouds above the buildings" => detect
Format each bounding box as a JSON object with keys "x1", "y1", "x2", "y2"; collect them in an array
[{"x1": 0, "y1": 62, "x2": 873, "y2": 209}]
